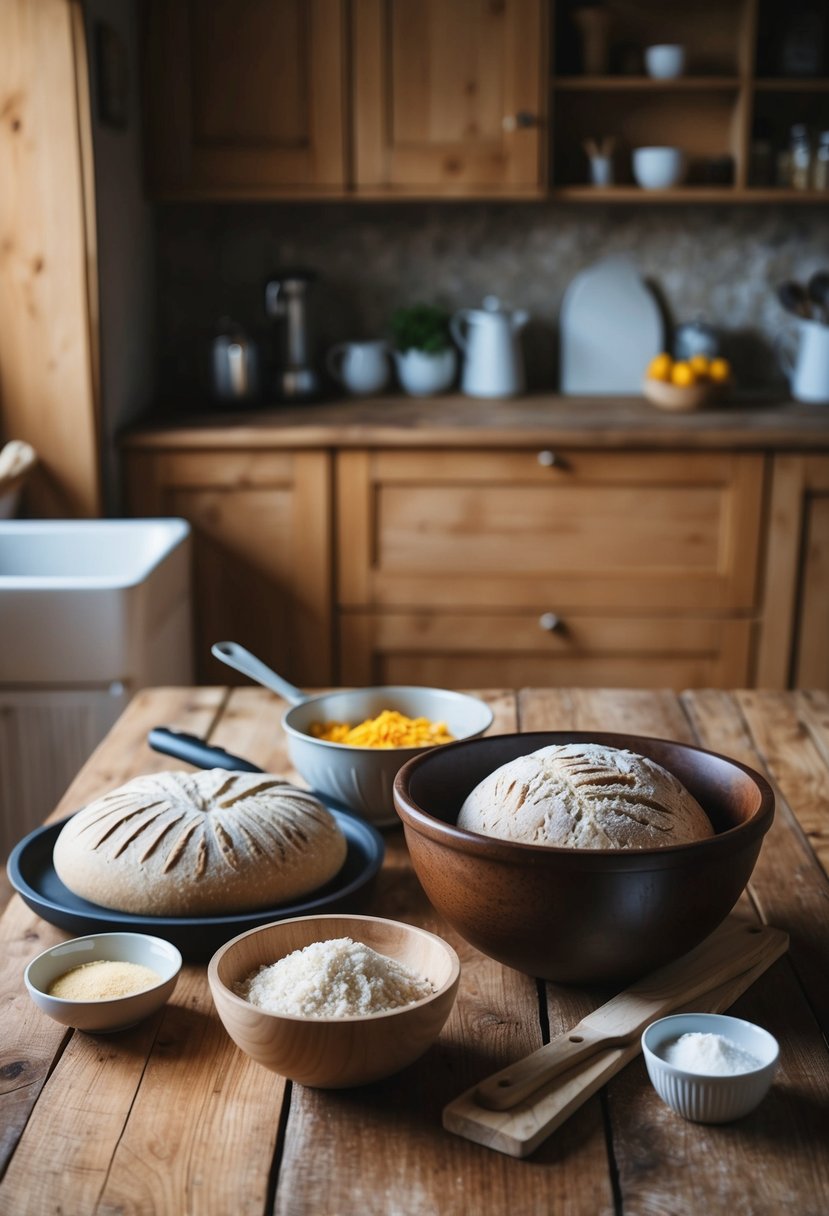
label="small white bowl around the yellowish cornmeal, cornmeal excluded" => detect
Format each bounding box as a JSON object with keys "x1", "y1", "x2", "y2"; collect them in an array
[{"x1": 23, "y1": 933, "x2": 181, "y2": 1034}]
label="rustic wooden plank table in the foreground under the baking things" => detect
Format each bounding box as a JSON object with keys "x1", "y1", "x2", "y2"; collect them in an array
[{"x1": 0, "y1": 688, "x2": 829, "y2": 1216}]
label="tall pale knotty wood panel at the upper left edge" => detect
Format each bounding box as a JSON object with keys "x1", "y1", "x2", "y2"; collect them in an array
[{"x1": 0, "y1": 0, "x2": 101, "y2": 516}]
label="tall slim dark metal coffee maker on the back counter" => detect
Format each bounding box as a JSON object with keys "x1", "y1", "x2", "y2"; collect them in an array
[{"x1": 265, "y1": 270, "x2": 322, "y2": 401}]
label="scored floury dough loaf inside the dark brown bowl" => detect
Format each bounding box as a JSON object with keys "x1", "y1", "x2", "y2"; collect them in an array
[{"x1": 457, "y1": 743, "x2": 714, "y2": 849}]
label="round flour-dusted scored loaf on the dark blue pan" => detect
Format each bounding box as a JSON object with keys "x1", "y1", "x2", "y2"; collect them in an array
[{"x1": 53, "y1": 769, "x2": 346, "y2": 917}]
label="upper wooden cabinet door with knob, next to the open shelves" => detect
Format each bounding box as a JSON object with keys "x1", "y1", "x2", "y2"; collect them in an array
[{"x1": 354, "y1": 0, "x2": 547, "y2": 198}]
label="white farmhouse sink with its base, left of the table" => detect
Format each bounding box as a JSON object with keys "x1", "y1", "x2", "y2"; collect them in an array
[{"x1": 0, "y1": 519, "x2": 193, "y2": 860}]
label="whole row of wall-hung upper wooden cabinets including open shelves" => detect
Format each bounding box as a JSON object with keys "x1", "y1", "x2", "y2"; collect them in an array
[{"x1": 141, "y1": 0, "x2": 829, "y2": 204}]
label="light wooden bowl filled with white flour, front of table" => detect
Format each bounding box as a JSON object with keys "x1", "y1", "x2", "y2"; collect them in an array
[{"x1": 208, "y1": 914, "x2": 461, "y2": 1088}]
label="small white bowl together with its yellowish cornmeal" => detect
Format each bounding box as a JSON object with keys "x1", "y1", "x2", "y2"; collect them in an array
[{"x1": 23, "y1": 933, "x2": 181, "y2": 1034}]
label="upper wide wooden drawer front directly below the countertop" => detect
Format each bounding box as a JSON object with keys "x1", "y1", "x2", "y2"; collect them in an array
[{"x1": 338, "y1": 450, "x2": 763, "y2": 612}]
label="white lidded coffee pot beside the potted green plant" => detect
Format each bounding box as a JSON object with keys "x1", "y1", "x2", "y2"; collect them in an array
[{"x1": 450, "y1": 295, "x2": 530, "y2": 396}]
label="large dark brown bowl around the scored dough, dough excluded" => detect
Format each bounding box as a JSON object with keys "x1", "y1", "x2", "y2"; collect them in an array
[{"x1": 394, "y1": 731, "x2": 774, "y2": 984}]
